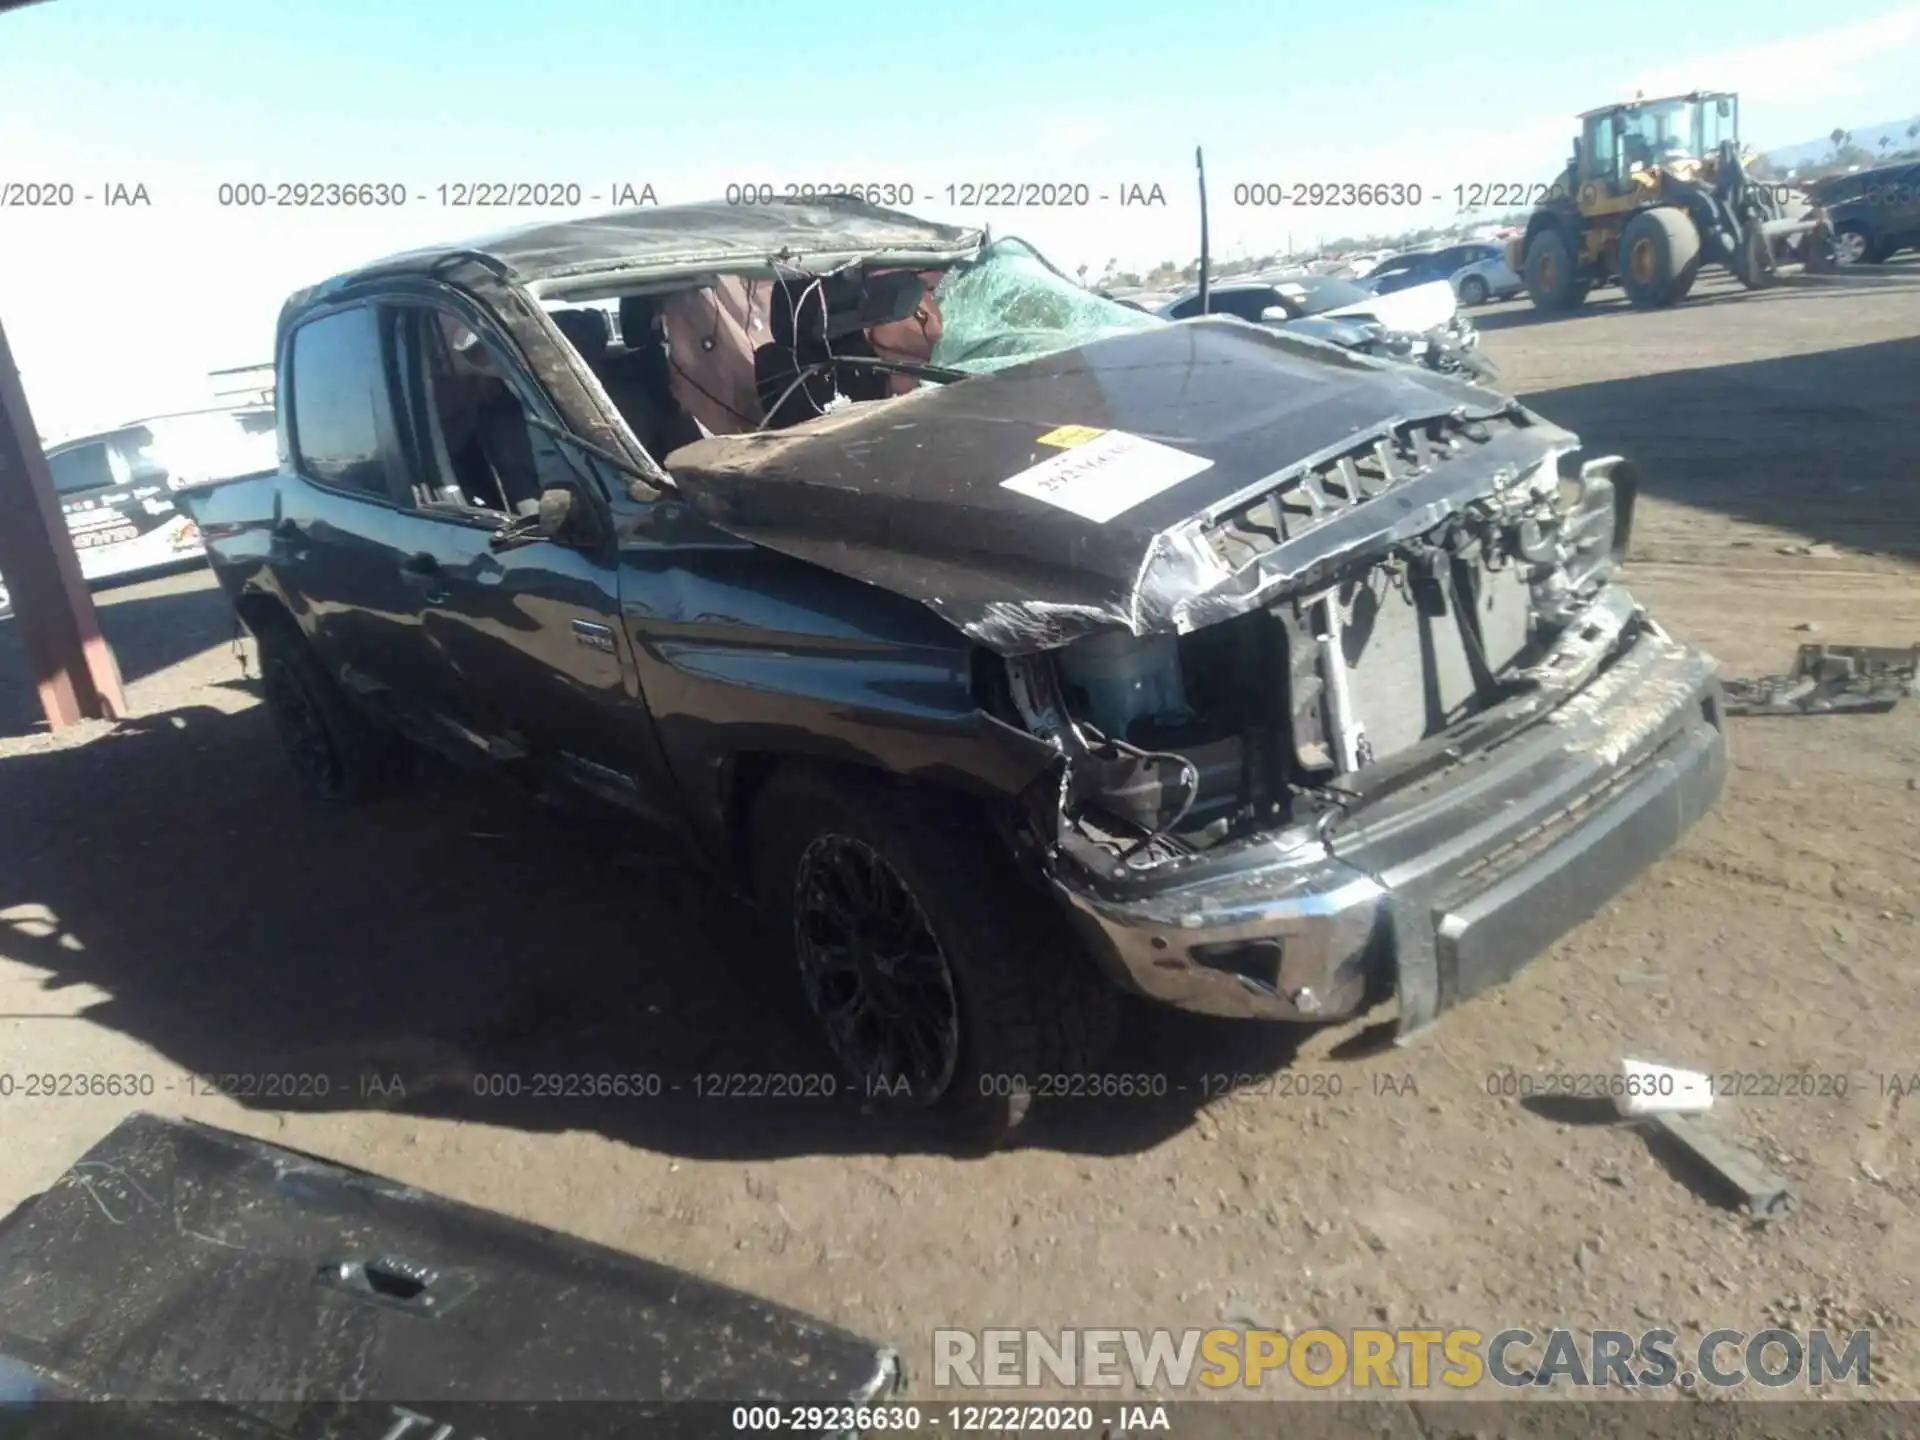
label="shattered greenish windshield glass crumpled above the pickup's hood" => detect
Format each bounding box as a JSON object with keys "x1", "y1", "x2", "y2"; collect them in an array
[{"x1": 933, "y1": 238, "x2": 1167, "y2": 372}]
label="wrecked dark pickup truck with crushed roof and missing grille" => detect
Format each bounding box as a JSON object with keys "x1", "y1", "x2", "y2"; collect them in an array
[{"x1": 186, "y1": 200, "x2": 1726, "y2": 1135}]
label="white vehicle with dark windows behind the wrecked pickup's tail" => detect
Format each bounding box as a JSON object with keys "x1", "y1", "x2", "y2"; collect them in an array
[{"x1": 0, "y1": 405, "x2": 278, "y2": 616}]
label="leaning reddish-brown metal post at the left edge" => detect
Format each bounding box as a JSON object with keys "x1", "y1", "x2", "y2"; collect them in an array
[{"x1": 0, "y1": 314, "x2": 127, "y2": 730}]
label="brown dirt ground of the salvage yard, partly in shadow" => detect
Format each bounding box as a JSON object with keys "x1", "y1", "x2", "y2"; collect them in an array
[{"x1": 0, "y1": 265, "x2": 1920, "y2": 1398}]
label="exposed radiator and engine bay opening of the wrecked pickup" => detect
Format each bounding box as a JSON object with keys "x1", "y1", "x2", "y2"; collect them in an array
[{"x1": 1004, "y1": 417, "x2": 1640, "y2": 868}]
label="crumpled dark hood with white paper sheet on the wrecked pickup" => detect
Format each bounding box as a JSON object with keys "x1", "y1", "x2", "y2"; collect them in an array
[{"x1": 668, "y1": 319, "x2": 1572, "y2": 655}]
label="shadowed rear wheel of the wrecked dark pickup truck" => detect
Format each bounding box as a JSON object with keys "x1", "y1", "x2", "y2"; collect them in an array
[{"x1": 259, "y1": 626, "x2": 405, "y2": 804}]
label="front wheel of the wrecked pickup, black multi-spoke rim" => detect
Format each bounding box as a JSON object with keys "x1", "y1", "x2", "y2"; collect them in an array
[{"x1": 755, "y1": 768, "x2": 1119, "y2": 1144}]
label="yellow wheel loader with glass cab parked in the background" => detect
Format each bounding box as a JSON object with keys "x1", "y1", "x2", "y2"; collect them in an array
[{"x1": 1507, "y1": 90, "x2": 1834, "y2": 311}]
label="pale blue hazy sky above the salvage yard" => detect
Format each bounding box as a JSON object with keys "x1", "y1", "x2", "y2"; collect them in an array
[{"x1": 0, "y1": 0, "x2": 1920, "y2": 434}]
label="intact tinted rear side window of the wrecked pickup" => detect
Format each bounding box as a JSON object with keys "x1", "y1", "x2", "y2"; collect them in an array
[{"x1": 292, "y1": 307, "x2": 390, "y2": 499}]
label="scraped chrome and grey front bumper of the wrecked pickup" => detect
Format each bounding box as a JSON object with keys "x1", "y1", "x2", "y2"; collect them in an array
[{"x1": 1052, "y1": 618, "x2": 1726, "y2": 1033}]
